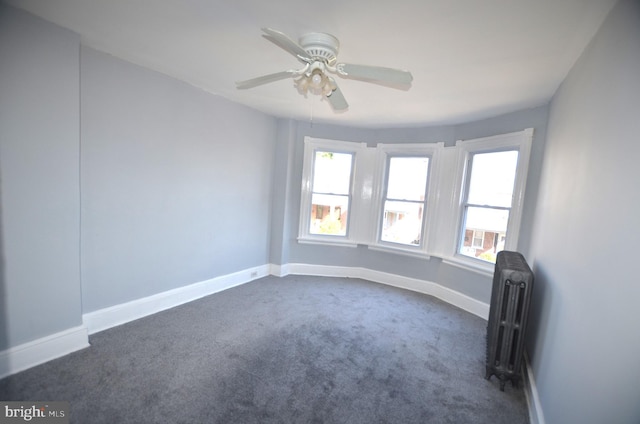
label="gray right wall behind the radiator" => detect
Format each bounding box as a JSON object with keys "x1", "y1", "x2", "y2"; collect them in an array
[{"x1": 528, "y1": 0, "x2": 640, "y2": 424}]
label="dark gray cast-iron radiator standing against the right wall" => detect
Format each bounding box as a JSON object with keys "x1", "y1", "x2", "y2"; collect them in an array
[{"x1": 485, "y1": 251, "x2": 533, "y2": 391}]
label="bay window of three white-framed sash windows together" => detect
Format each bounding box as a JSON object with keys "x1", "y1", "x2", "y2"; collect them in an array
[{"x1": 298, "y1": 129, "x2": 533, "y2": 274}]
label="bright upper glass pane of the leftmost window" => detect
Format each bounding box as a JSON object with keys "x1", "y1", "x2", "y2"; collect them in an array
[{"x1": 312, "y1": 151, "x2": 353, "y2": 195}]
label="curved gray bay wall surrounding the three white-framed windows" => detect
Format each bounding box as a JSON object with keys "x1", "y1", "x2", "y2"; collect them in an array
[{"x1": 272, "y1": 106, "x2": 547, "y2": 302}]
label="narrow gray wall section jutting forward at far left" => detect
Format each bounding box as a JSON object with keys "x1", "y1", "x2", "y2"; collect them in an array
[{"x1": 0, "y1": 4, "x2": 82, "y2": 350}]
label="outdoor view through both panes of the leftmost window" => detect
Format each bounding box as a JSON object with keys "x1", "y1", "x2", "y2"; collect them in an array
[{"x1": 309, "y1": 151, "x2": 353, "y2": 236}]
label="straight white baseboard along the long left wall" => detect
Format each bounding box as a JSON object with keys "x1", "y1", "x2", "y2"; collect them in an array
[{"x1": 82, "y1": 265, "x2": 270, "y2": 334}]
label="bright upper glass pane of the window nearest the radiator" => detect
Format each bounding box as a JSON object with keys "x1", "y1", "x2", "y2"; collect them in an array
[{"x1": 468, "y1": 150, "x2": 518, "y2": 207}]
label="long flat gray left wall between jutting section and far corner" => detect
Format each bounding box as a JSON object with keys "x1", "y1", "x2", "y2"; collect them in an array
[{"x1": 81, "y1": 47, "x2": 276, "y2": 312}]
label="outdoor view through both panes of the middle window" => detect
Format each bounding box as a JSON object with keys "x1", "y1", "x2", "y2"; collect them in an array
[{"x1": 380, "y1": 157, "x2": 429, "y2": 246}]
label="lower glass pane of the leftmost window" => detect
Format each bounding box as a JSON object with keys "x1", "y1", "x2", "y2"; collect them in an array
[{"x1": 309, "y1": 193, "x2": 349, "y2": 236}]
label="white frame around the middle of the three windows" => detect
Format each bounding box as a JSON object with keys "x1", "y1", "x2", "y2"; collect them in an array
[{"x1": 369, "y1": 143, "x2": 444, "y2": 258}]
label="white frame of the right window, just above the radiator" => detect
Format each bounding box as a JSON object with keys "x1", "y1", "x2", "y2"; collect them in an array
[{"x1": 440, "y1": 128, "x2": 533, "y2": 275}]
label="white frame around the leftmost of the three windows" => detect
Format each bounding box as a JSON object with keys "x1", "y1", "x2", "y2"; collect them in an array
[{"x1": 298, "y1": 137, "x2": 367, "y2": 247}]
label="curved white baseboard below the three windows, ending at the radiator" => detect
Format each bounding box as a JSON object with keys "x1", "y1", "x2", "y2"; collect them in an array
[{"x1": 289, "y1": 263, "x2": 489, "y2": 320}]
